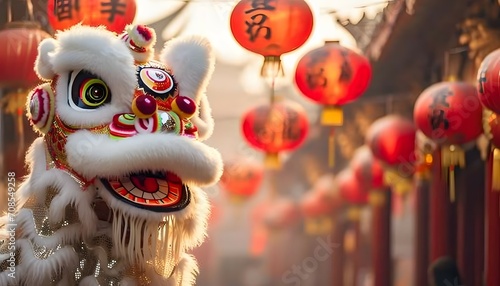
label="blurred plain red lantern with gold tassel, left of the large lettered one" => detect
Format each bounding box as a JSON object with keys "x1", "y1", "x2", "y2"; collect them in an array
[{"x1": 366, "y1": 115, "x2": 417, "y2": 194}]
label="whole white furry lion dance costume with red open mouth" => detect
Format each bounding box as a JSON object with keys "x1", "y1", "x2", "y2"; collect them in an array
[{"x1": 0, "y1": 25, "x2": 222, "y2": 286}]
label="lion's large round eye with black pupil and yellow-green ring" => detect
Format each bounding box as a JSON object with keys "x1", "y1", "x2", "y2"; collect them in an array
[{"x1": 68, "y1": 70, "x2": 111, "y2": 110}]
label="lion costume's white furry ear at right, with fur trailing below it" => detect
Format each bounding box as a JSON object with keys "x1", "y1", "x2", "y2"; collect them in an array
[{"x1": 160, "y1": 36, "x2": 215, "y2": 140}]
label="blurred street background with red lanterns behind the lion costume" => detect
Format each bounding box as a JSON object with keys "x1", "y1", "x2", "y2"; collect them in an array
[{"x1": 0, "y1": 0, "x2": 500, "y2": 286}]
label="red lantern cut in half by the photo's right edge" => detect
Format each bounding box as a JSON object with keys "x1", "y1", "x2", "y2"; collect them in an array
[{"x1": 477, "y1": 49, "x2": 500, "y2": 113}]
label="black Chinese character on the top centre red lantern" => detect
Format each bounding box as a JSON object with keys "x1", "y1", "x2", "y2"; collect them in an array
[{"x1": 245, "y1": 0, "x2": 276, "y2": 42}]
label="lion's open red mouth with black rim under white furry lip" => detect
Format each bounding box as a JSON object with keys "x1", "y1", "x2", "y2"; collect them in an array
[{"x1": 101, "y1": 171, "x2": 189, "y2": 212}]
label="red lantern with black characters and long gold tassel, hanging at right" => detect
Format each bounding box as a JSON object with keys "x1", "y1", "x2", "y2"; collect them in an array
[{"x1": 413, "y1": 82, "x2": 483, "y2": 201}]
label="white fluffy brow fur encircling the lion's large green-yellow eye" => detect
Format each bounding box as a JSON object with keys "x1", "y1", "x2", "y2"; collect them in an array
[{"x1": 35, "y1": 26, "x2": 137, "y2": 127}]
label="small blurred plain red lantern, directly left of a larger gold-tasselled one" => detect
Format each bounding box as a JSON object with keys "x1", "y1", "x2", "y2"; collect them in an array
[{"x1": 351, "y1": 145, "x2": 384, "y2": 190}]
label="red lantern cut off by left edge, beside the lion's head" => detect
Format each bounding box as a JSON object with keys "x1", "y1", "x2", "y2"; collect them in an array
[{"x1": 0, "y1": 22, "x2": 50, "y2": 89}]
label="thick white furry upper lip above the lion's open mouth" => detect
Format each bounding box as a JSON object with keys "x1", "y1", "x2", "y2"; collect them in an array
[{"x1": 66, "y1": 130, "x2": 222, "y2": 185}]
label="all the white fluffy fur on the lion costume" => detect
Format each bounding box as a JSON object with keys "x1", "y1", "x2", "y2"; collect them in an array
[{"x1": 5, "y1": 26, "x2": 222, "y2": 286}]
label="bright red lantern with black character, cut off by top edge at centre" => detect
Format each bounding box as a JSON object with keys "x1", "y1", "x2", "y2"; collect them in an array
[{"x1": 230, "y1": 0, "x2": 313, "y2": 78}]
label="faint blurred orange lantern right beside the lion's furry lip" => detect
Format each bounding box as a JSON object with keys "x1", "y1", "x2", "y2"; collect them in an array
[{"x1": 219, "y1": 158, "x2": 264, "y2": 203}]
